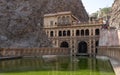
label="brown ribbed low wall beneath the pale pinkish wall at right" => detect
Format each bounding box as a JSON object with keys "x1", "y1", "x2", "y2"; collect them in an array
[{"x1": 98, "y1": 47, "x2": 120, "y2": 61}]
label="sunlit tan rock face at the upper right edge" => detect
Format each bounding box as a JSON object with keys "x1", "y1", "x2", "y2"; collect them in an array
[{"x1": 110, "y1": 0, "x2": 120, "y2": 29}]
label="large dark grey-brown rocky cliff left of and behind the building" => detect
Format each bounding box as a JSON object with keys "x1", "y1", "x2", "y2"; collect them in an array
[{"x1": 0, "y1": 0, "x2": 88, "y2": 48}]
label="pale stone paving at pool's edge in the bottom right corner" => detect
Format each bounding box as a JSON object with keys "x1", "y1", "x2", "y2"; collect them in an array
[{"x1": 110, "y1": 58, "x2": 120, "y2": 75}]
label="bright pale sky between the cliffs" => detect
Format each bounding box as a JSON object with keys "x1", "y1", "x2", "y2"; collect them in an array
[{"x1": 82, "y1": 0, "x2": 114, "y2": 14}]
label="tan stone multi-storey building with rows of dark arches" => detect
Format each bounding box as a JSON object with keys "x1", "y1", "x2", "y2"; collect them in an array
[{"x1": 44, "y1": 11, "x2": 102, "y2": 54}]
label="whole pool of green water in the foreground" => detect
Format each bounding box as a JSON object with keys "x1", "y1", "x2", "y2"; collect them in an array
[{"x1": 0, "y1": 57, "x2": 115, "y2": 75}]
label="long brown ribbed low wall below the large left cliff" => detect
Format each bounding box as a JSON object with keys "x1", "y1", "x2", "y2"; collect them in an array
[{"x1": 0, "y1": 48, "x2": 70, "y2": 57}]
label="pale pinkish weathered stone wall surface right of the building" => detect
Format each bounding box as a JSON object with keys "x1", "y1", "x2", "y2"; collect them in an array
[{"x1": 99, "y1": 29, "x2": 120, "y2": 47}]
